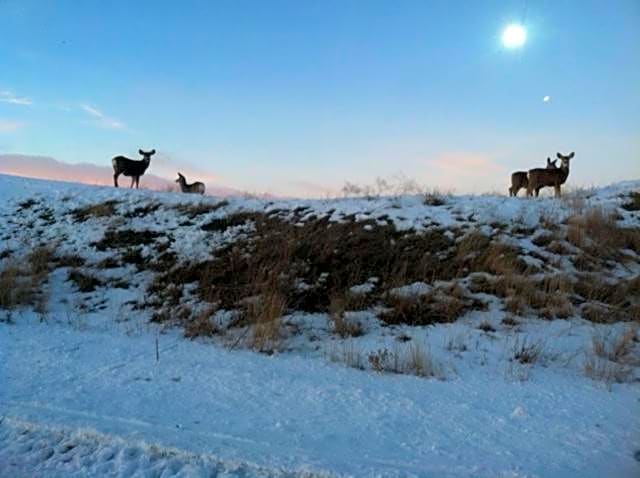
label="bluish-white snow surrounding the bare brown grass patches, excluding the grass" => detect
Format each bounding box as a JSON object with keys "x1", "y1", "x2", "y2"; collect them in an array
[{"x1": 0, "y1": 176, "x2": 640, "y2": 477}]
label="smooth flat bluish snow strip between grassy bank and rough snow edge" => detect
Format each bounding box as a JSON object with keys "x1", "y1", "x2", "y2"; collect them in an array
[{"x1": 0, "y1": 323, "x2": 640, "y2": 477}]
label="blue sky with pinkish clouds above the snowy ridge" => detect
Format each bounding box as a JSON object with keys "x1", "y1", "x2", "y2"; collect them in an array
[{"x1": 0, "y1": 0, "x2": 640, "y2": 196}]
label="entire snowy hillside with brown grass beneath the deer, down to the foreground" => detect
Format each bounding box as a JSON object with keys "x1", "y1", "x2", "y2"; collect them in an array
[{"x1": 0, "y1": 176, "x2": 640, "y2": 477}]
